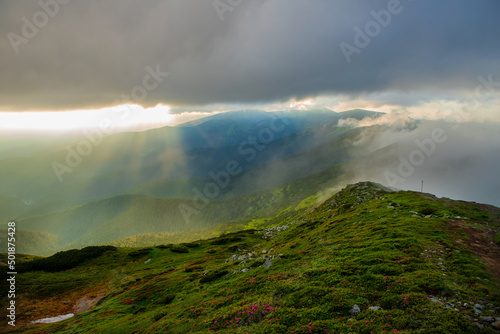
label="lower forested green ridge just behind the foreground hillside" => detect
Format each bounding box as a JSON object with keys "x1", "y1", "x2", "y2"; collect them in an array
[{"x1": 11, "y1": 167, "x2": 343, "y2": 255}]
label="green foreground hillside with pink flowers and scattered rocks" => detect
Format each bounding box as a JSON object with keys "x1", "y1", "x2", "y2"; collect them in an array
[{"x1": 2, "y1": 183, "x2": 500, "y2": 334}]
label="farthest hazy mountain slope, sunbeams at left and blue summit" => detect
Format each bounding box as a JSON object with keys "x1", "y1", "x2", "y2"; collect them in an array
[{"x1": 0, "y1": 110, "x2": 348, "y2": 214}]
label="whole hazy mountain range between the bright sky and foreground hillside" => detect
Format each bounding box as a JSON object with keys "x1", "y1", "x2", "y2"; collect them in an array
[{"x1": 0, "y1": 109, "x2": 500, "y2": 255}]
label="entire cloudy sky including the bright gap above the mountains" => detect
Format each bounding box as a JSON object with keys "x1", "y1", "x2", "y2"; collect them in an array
[{"x1": 0, "y1": 0, "x2": 500, "y2": 136}]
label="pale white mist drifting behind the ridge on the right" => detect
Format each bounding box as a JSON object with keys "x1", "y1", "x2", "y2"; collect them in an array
[{"x1": 343, "y1": 120, "x2": 500, "y2": 206}]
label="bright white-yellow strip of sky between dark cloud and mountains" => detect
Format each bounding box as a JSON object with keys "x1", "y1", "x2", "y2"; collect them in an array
[{"x1": 0, "y1": 95, "x2": 500, "y2": 137}]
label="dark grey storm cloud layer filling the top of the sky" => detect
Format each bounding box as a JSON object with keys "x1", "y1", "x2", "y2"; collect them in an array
[{"x1": 0, "y1": 0, "x2": 500, "y2": 110}]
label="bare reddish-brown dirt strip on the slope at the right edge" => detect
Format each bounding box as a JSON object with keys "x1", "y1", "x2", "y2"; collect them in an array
[{"x1": 450, "y1": 220, "x2": 500, "y2": 281}]
